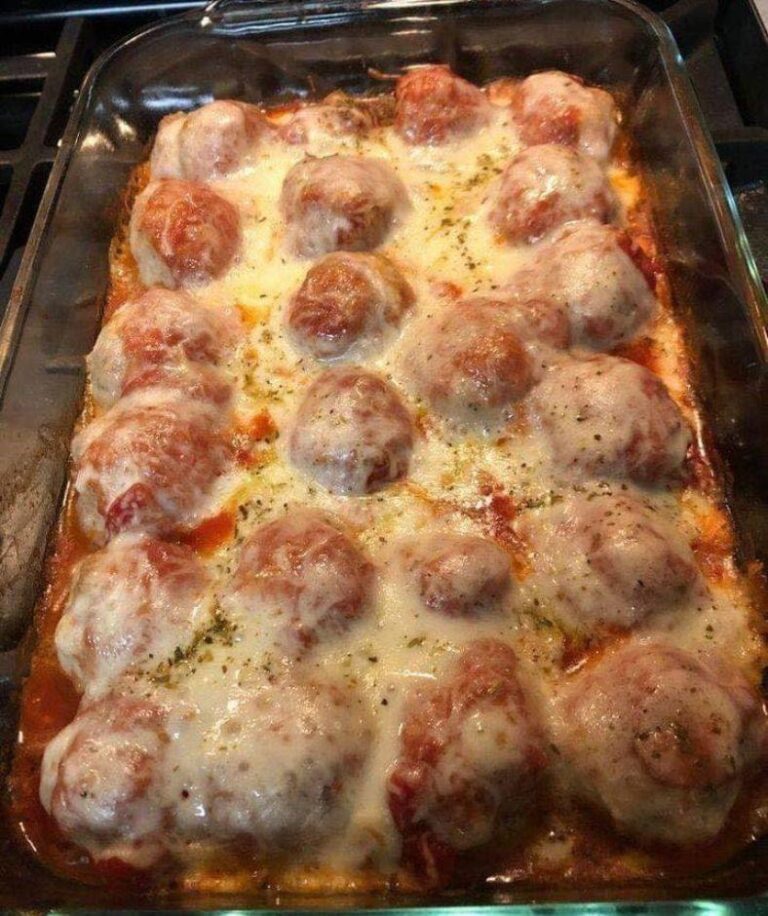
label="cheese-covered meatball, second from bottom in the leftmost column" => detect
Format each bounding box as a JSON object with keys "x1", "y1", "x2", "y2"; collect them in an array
[{"x1": 56, "y1": 534, "x2": 209, "y2": 696}]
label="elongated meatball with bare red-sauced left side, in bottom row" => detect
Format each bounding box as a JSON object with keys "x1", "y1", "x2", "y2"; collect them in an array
[{"x1": 387, "y1": 639, "x2": 546, "y2": 883}]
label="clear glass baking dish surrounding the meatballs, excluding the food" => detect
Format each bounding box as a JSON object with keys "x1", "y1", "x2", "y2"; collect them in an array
[{"x1": 0, "y1": 0, "x2": 768, "y2": 914}]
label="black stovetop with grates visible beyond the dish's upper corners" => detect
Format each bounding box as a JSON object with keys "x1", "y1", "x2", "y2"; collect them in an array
[{"x1": 0, "y1": 0, "x2": 768, "y2": 318}]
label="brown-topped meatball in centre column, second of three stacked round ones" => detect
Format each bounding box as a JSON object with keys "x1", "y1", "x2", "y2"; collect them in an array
[{"x1": 287, "y1": 252, "x2": 414, "y2": 359}]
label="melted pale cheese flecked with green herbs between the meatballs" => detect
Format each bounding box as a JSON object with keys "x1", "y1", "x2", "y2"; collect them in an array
[{"x1": 61, "y1": 93, "x2": 758, "y2": 873}]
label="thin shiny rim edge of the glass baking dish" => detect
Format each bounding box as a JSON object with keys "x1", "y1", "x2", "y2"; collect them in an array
[{"x1": 0, "y1": 0, "x2": 768, "y2": 916}]
